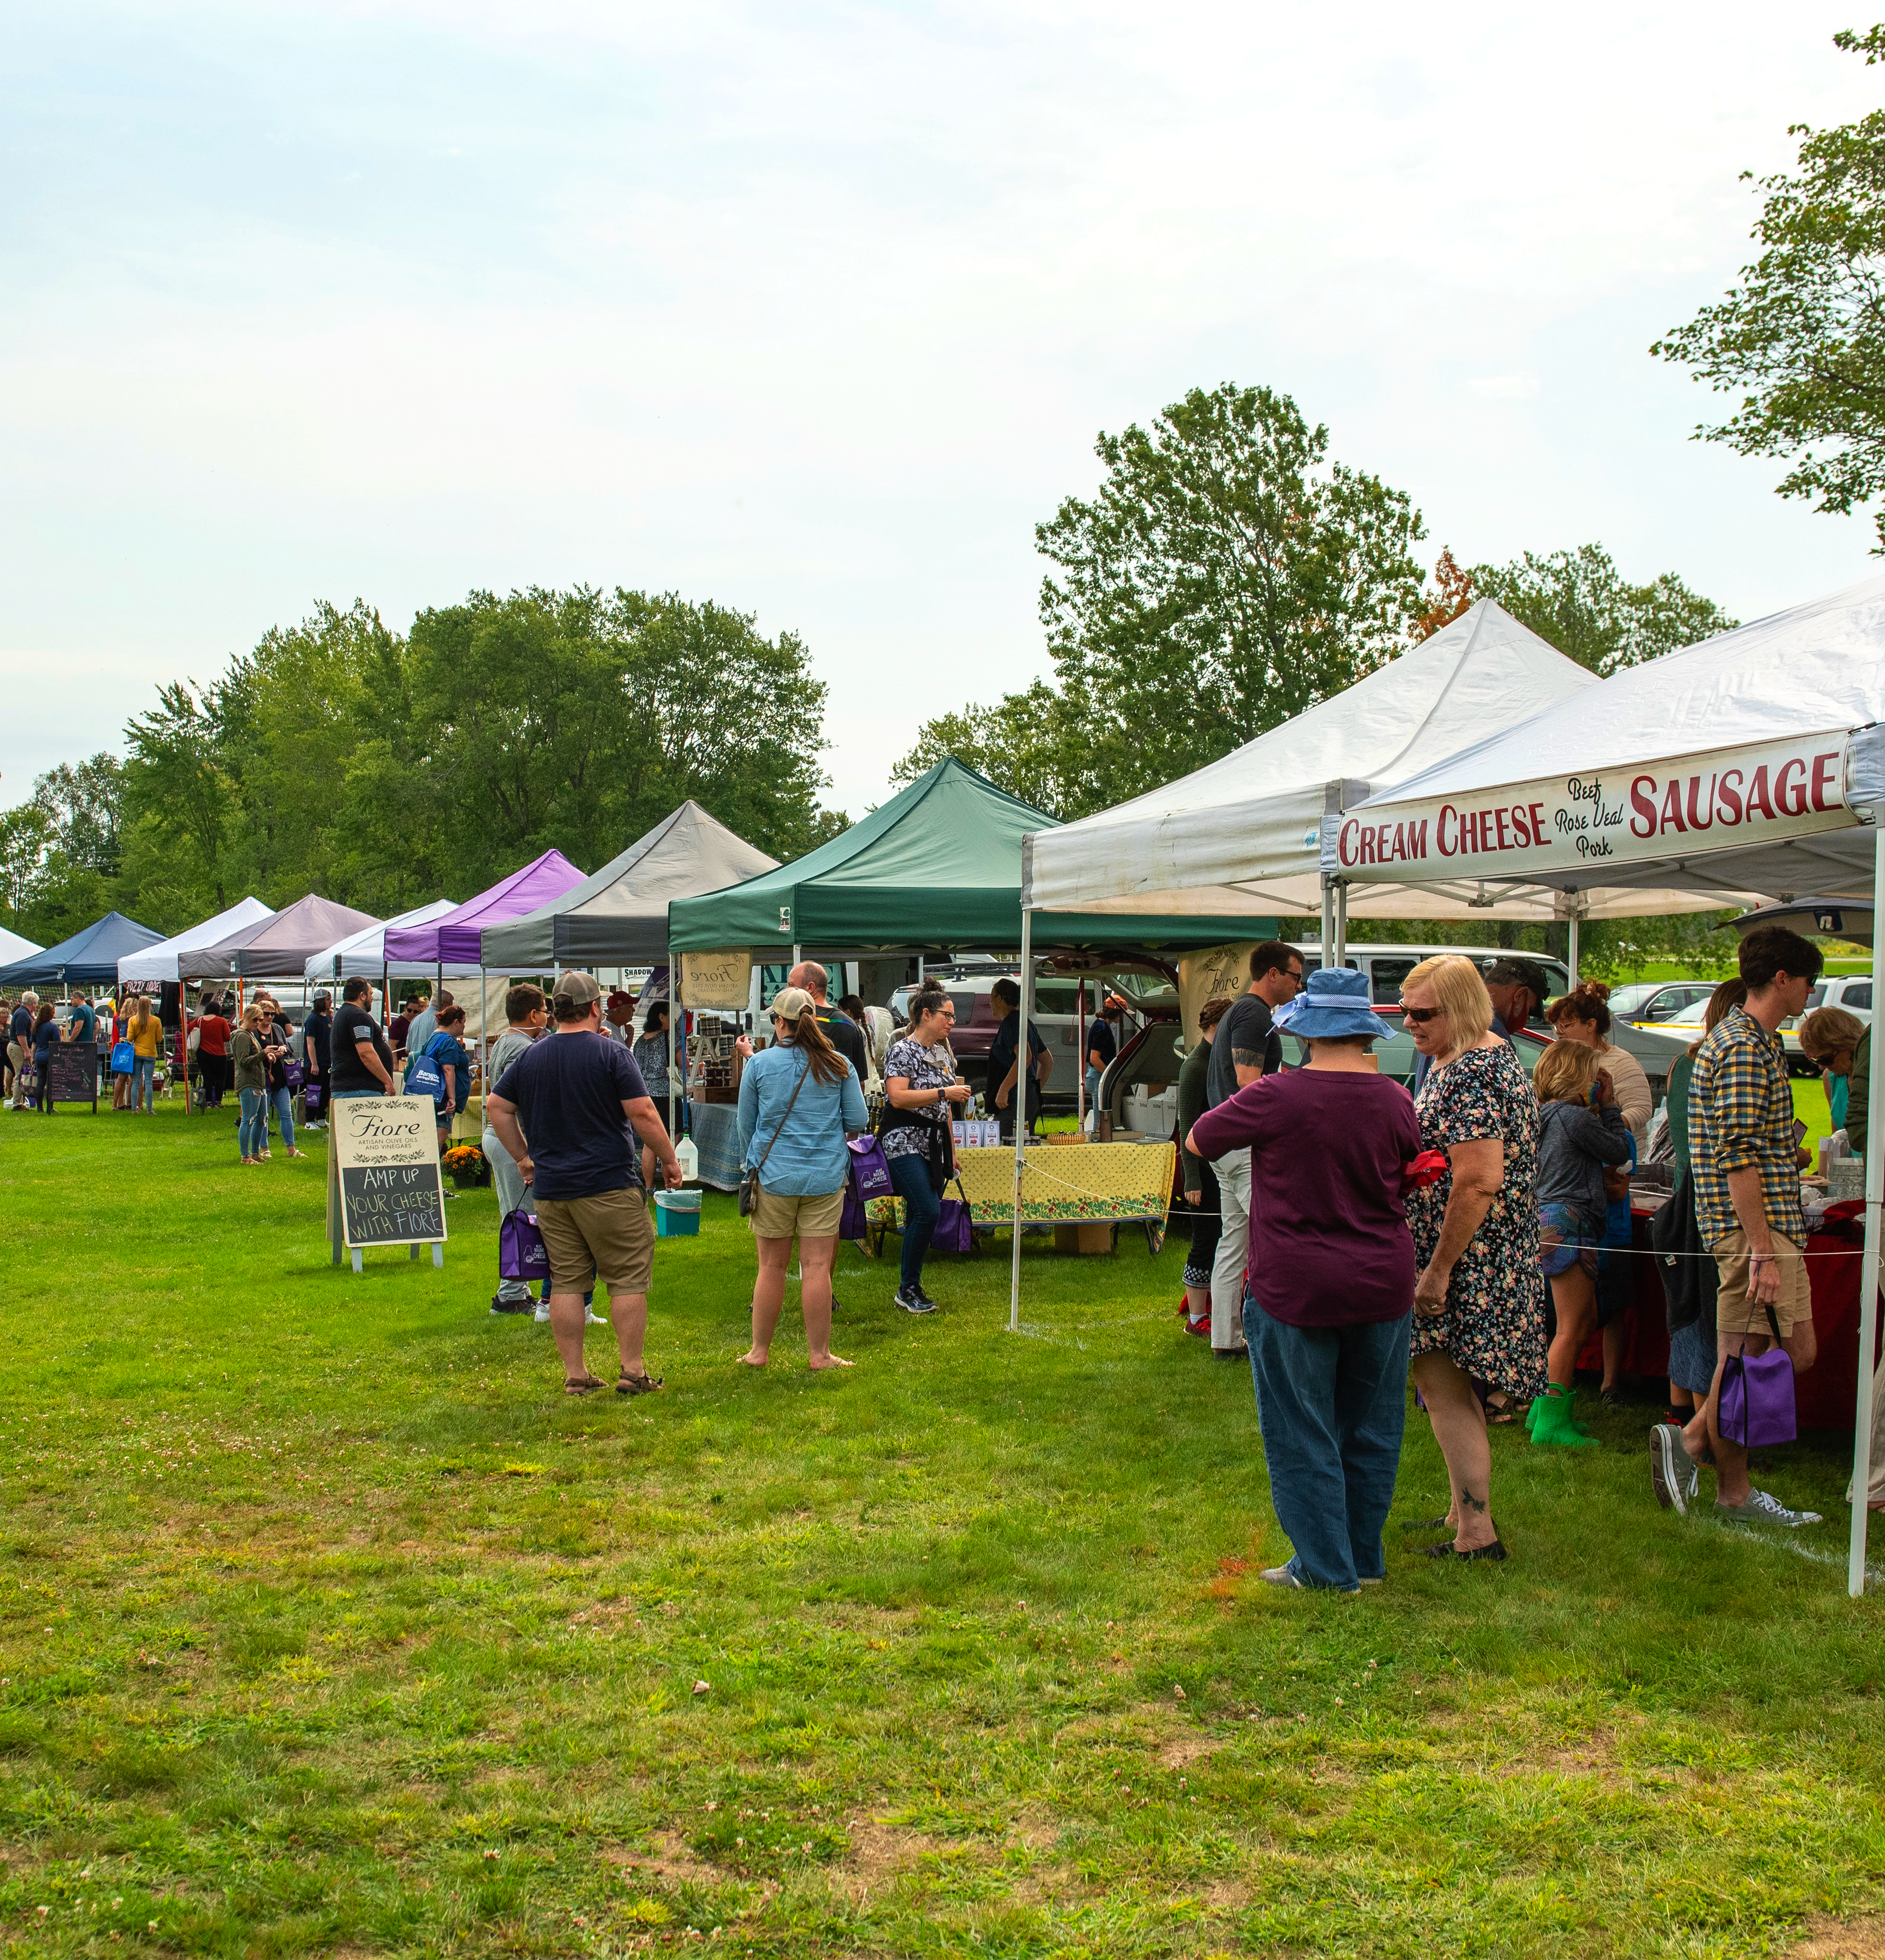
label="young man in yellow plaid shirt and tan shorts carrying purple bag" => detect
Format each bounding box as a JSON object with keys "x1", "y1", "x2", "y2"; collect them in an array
[{"x1": 1650, "y1": 925, "x2": 1820, "y2": 1527}]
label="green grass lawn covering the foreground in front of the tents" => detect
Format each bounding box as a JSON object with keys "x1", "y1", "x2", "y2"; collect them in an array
[{"x1": 0, "y1": 1111, "x2": 1885, "y2": 1960}]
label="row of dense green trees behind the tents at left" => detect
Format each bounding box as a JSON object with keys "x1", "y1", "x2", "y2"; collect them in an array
[{"x1": 0, "y1": 586, "x2": 846, "y2": 945}]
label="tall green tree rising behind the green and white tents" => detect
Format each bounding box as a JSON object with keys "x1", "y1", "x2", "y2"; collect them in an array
[{"x1": 895, "y1": 384, "x2": 1425, "y2": 816}]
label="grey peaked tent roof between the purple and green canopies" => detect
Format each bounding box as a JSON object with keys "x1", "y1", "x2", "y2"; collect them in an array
[{"x1": 480, "y1": 798, "x2": 778, "y2": 972}]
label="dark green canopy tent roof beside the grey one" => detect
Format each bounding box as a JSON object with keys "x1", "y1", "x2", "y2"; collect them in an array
[{"x1": 668, "y1": 757, "x2": 1279, "y2": 963}]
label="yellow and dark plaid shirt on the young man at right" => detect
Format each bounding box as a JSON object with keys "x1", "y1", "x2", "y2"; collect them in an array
[{"x1": 1689, "y1": 1007, "x2": 1807, "y2": 1245}]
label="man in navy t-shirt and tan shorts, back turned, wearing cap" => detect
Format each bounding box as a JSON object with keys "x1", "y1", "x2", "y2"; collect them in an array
[{"x1": 484, "y1": 974, "x2": 682, "y2": 1396}]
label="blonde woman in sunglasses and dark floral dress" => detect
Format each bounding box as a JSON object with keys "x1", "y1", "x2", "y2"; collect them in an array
[{"x1": 1401, "y1": 953, "x2": 1546, "y2": 1560}]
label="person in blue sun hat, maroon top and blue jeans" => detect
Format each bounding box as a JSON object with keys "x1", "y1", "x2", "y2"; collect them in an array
[{"x1": 1188, "y1": 968, "x2": 1421, "y2": 1593}]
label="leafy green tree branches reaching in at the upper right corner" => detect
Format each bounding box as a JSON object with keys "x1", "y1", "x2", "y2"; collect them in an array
[{"x1": 1650, "y1": 27, "x2": 1885, "y2": 553}]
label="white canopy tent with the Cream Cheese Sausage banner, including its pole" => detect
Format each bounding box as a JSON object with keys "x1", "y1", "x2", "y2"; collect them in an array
[{"x1": 1320, "y1": 578, "x2": 1885, "y2": 1595}]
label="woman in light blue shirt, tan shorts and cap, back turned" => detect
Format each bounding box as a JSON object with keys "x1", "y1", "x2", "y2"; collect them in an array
[{"x1": 739, "y1": 986, "x2": 870, "y2": 1368}]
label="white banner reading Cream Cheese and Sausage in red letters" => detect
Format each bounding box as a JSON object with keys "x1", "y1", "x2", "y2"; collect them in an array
[{"x1": 1323, "y1": 733, "x2": 1858, "y2": 882}]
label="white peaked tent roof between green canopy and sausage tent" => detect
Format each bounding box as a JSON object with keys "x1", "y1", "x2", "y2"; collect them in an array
[{"x1": 1027, "y1": 600, "x2": 1597, "y2": 911}]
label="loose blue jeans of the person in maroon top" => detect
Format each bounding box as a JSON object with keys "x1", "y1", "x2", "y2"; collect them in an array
[{"x1": 1244, "y1": 1294, "x2": 1413, "y2": 1592}]
